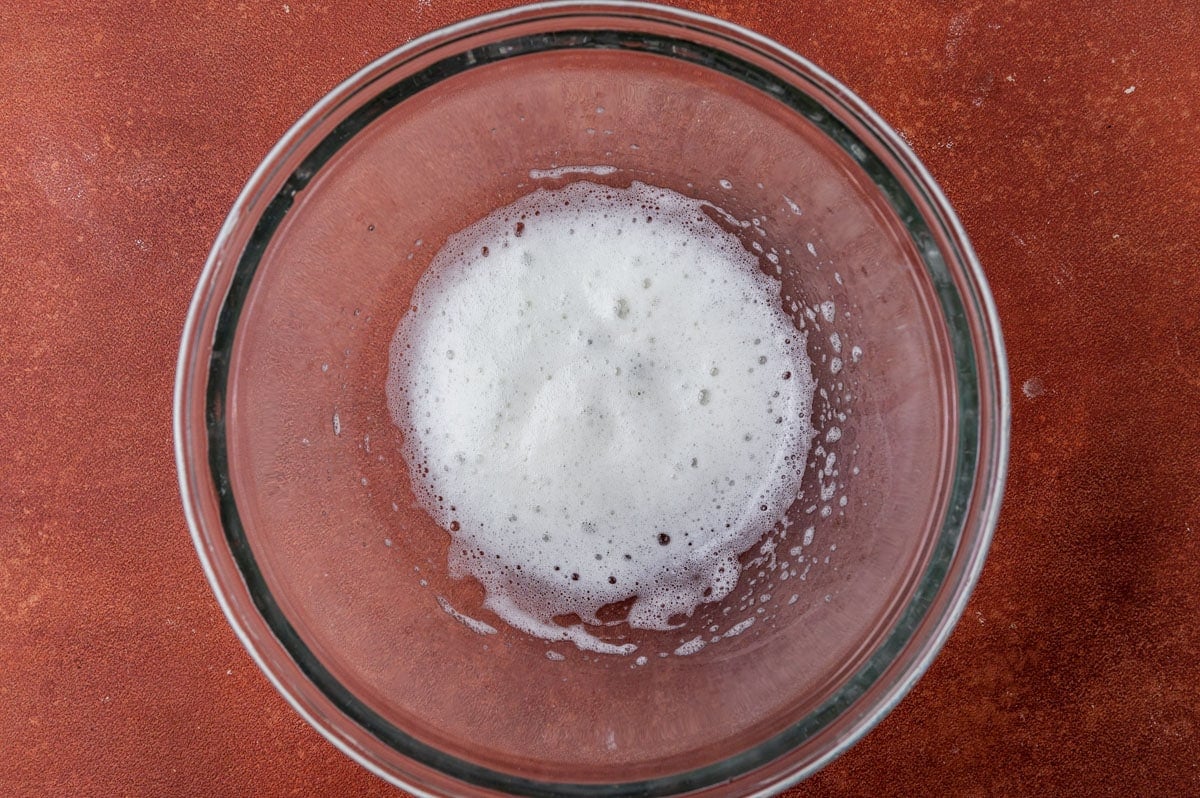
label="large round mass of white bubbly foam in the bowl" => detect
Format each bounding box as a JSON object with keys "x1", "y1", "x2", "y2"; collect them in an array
[{"x1": 388, "y1": 182, "x2": 814, "y2": 654}]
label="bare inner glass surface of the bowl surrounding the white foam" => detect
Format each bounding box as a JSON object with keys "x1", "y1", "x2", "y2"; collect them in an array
[{"x1": 211, "y1": 21, "x2": 958, "y2": 784}]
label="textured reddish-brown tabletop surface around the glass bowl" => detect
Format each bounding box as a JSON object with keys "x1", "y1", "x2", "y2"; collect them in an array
[{"x1": 0, "y1": 0, "x2": 1200, "y2": 796}]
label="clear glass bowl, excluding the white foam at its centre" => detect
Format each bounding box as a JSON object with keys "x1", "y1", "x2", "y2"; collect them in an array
[{"x1": 175, "y1": 4, "x2": 1009, "y2": 796}]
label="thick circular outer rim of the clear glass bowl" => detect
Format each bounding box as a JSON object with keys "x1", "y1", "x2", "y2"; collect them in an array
[{"x1": 173, "y1": 0, "x2": 1012, "y2": 796}]
